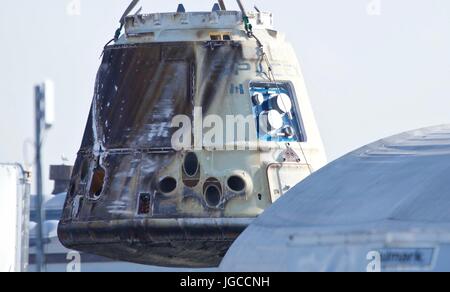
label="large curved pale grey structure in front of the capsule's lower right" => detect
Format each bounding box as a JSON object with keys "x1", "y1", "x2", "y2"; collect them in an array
[{"x1": 221, "y1": 125, "x2": 450, "y2": 271}]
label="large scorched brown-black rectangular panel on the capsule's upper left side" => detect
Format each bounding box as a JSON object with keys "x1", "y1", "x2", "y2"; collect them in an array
[{"x1": 97, "y1": 44, "x2": 193, "y2": 148}]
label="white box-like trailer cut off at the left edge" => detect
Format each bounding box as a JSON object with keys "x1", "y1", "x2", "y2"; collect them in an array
[{"x1": 0, "y1": 164, "x2": 30, "y2": 272}]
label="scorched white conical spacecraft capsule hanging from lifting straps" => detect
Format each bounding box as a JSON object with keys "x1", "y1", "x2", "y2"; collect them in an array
[{"x1": 58, "y1": 2, "x2": 326, "y2": 267}]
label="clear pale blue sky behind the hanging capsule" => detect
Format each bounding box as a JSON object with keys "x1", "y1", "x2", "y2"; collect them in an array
[{"x1": 0, "y1": 0, "x2": 450, "y2": 191}]
